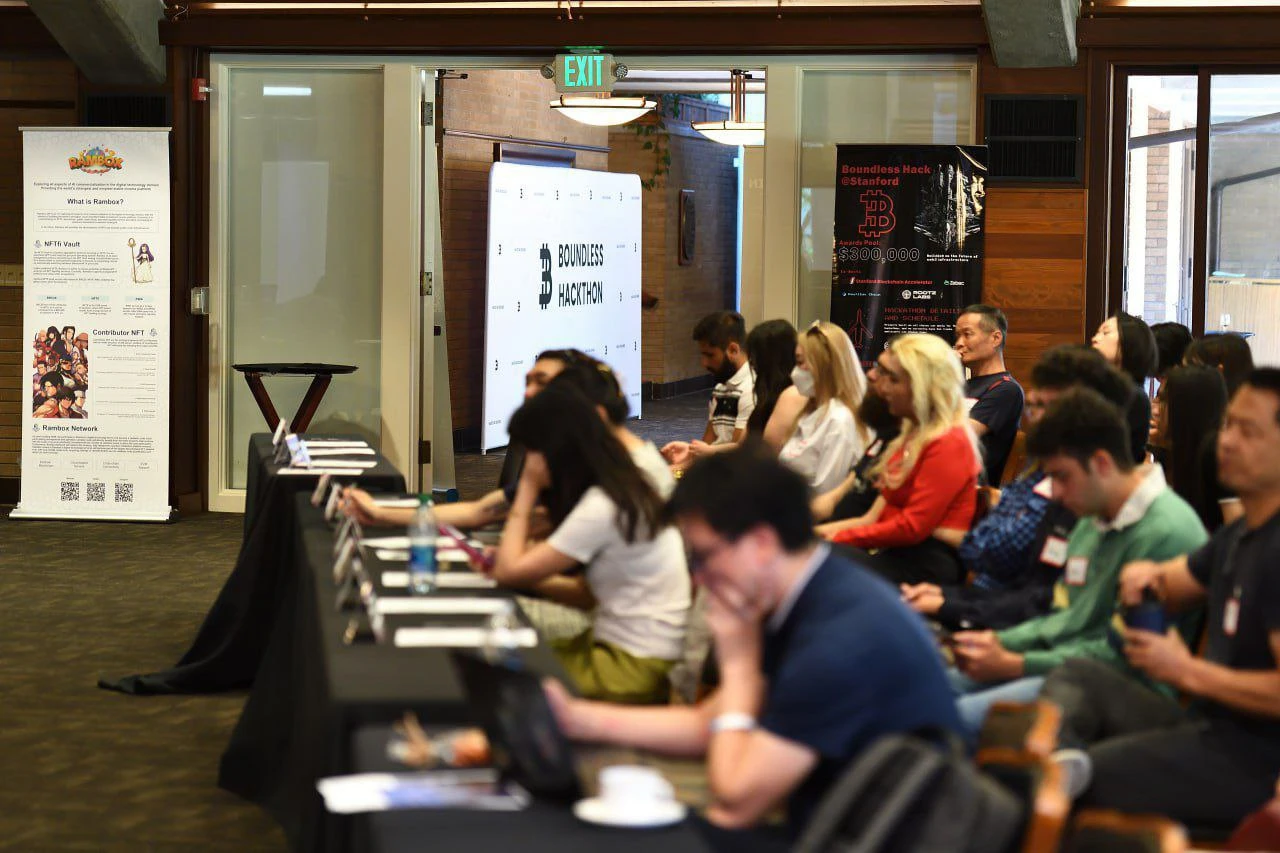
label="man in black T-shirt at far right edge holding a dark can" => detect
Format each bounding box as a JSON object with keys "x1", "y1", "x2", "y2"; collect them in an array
[{"x1": 1044, "y1": 368, "x2": 1280, "y2": 829}]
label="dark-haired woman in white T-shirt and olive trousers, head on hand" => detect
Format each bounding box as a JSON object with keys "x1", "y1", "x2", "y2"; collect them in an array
[{"x1": 492, "y1": 383, "x2": 690, "y2": 704}]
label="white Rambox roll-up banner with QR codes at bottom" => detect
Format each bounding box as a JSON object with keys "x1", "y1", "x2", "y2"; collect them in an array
[{"x1": 13, "y1": 128, "x2": 170, "y2": 521}]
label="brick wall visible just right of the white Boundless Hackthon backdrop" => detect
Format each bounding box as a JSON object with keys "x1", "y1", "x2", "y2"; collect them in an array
[{"x1": 609, "y1": 101, "x2": 737, "y2": 384}]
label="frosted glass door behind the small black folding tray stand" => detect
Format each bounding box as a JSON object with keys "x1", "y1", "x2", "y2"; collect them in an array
[{"x1": 209, "y1": 56, "x2": 434, "y2": 511}]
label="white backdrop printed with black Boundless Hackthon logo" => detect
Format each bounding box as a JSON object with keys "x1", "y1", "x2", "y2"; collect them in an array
[{"x1": 481, "y1": 163, "x2": 643, "y2": 450}]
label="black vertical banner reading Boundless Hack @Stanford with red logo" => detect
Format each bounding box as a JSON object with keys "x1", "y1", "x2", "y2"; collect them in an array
[{"x1": 831, "y1": 145, "x2": 987, "y2": 366}]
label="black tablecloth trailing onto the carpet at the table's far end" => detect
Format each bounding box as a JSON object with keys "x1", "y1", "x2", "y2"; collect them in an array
[{"x1": 99, "y1": 433, "x2": 404, "y2": 694}]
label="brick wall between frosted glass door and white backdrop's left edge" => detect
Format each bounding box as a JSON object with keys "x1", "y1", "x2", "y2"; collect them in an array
[{"x1": 440, "y1": 70, "x2": 608, "y2": 430}]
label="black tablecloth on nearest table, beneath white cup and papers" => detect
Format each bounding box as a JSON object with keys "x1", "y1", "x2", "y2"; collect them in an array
[{"x1": 351, "y1": 726, "x2": 708, "y2": 853}]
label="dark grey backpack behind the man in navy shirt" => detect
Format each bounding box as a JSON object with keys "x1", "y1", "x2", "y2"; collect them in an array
[{"x1": 794, "y1": 734, "x2": 1024, "y2": 853}]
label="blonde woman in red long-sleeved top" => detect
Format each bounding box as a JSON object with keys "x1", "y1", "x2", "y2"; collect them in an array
[{"x1": 818, "y1": 334, "x2": 980, "y2": 584}]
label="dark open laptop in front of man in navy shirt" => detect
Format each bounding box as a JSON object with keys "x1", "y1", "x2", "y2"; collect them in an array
[{"x1": 449, "y1": 651, "x2": 582, "y2": 803}]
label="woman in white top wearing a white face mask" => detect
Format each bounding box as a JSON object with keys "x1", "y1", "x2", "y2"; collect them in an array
[{"x1": 778, "y1": 320, "x2": 870, "y2": 494}]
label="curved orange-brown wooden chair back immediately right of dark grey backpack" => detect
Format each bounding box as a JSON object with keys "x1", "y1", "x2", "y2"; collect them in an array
[{"x1": 974, "y1": 747, "x2": 1071, "y2": 853}]
